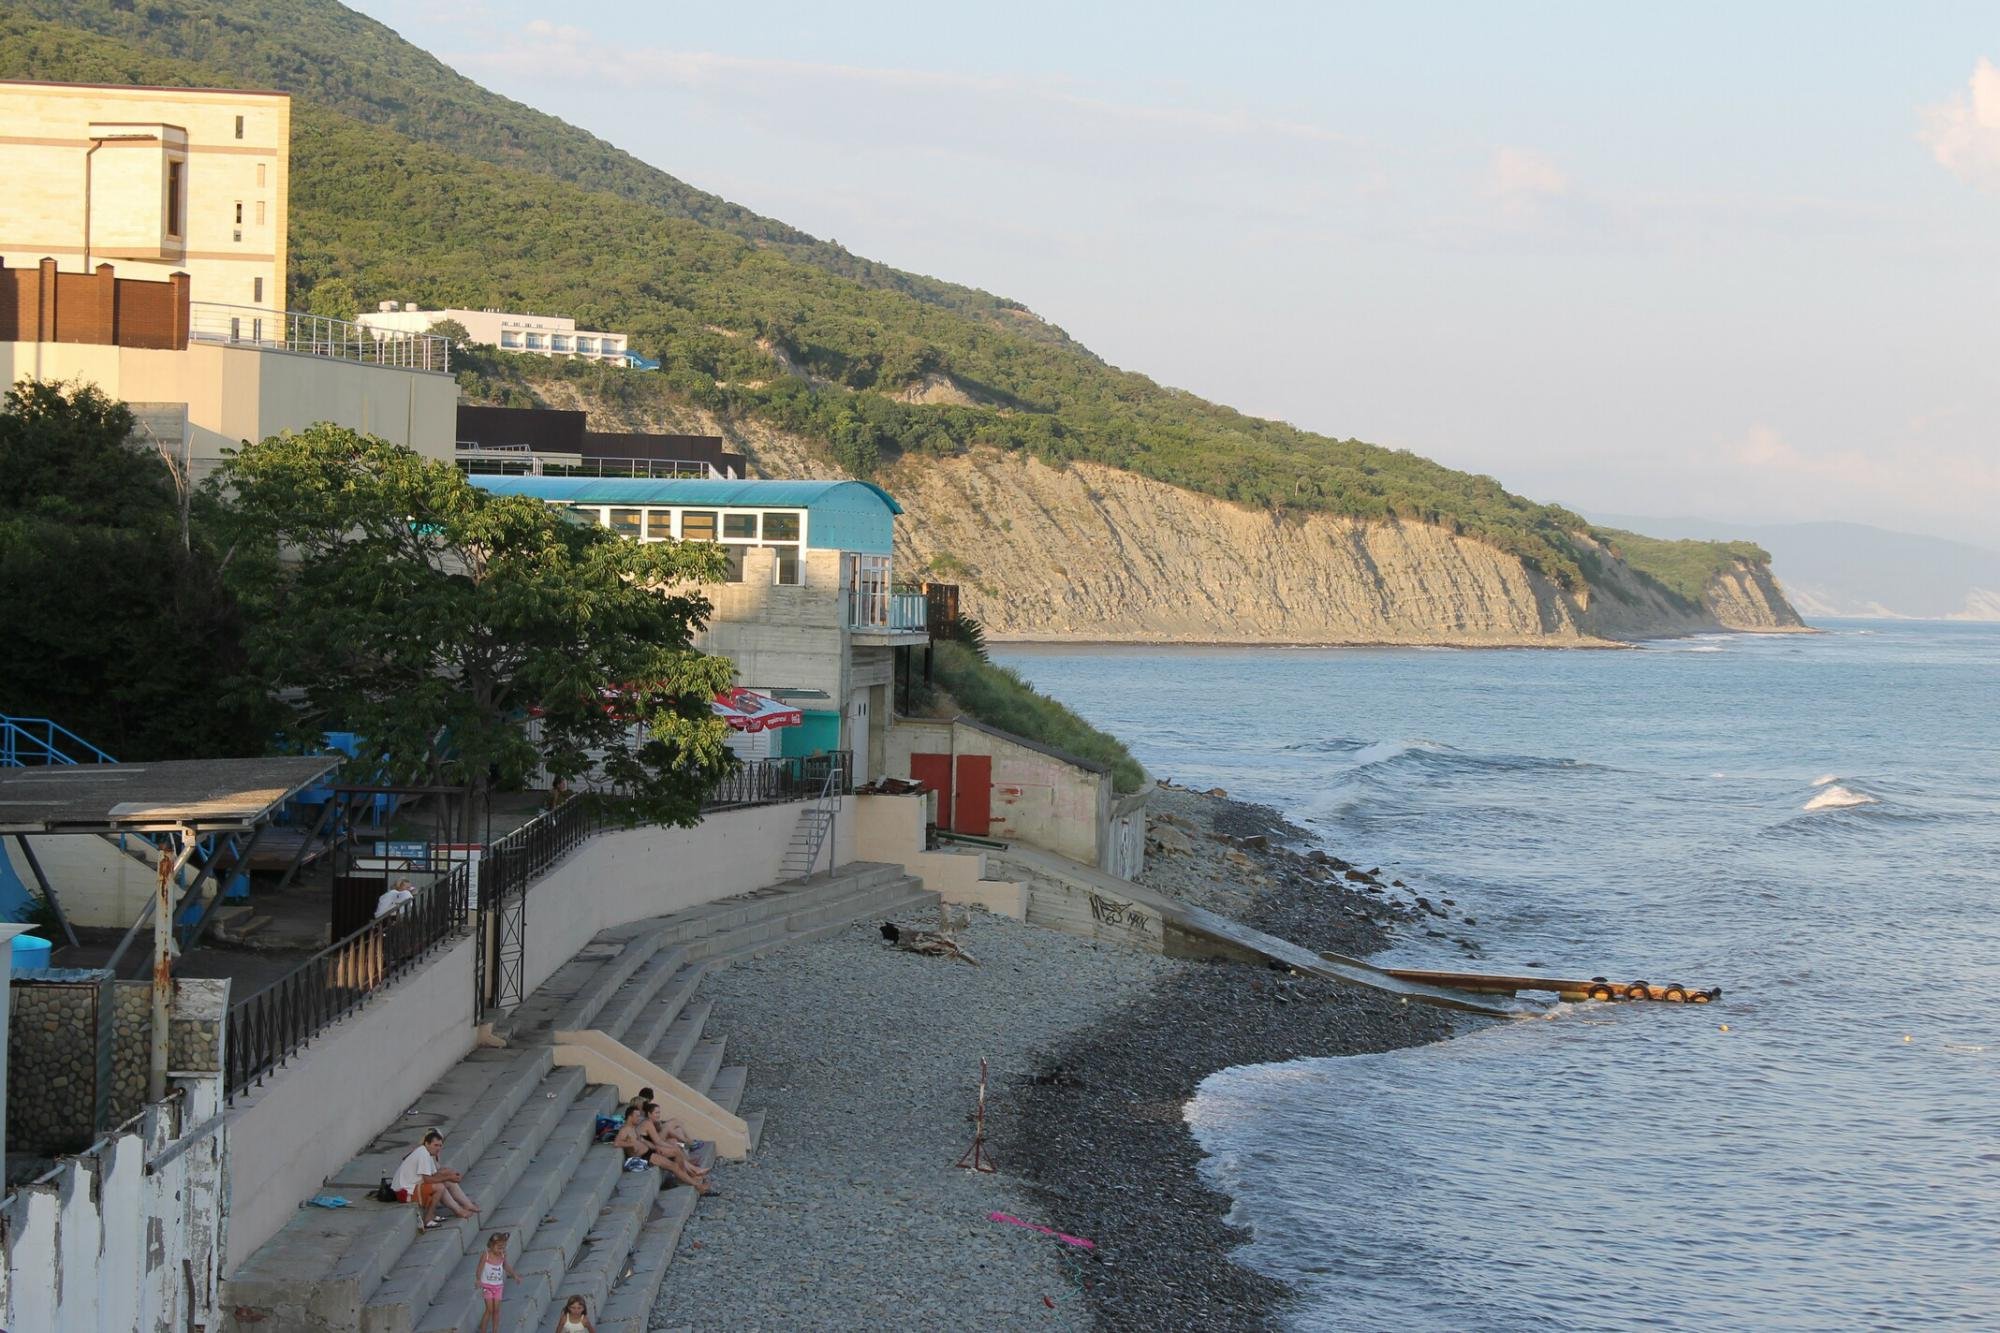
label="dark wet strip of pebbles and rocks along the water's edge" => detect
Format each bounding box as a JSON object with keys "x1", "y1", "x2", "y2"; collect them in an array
[{"x1": 1006, "y1": 787, "x2": 1470, "y2": 1329}]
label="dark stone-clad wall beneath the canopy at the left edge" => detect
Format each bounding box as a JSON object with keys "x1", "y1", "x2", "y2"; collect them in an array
[{"x1": 6, "y1": 964, "x2": 228, "y2": 1153}]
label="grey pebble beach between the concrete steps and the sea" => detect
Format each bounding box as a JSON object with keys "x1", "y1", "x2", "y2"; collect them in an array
[{"x1": 652, "y1": 785, "x2": 1450, "y2": 1331}]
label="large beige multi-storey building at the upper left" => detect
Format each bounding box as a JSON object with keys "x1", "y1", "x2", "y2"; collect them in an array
[{"x1": 0, "y1": 82, "x2": 292, "y2": 312}]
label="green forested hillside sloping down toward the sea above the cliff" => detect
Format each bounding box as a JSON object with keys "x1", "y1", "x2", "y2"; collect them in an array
[{"x1": 0, "y1": 0, "x2": 1792, "y2": 624}]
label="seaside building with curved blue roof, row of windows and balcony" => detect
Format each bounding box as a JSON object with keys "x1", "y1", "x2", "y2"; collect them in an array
[{"x1": 470, "y1": 476, "x2": 930, "y2": 783}]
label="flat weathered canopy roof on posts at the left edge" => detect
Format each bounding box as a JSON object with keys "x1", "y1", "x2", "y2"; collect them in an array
[{"x1": 0, "y1": 755, "x2": 346, "y2": 837}]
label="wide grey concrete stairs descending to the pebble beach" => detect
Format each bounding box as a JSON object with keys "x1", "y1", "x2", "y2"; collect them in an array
[{"x1": 224, "y1": 863, "x2": 936, "y2": 1333}]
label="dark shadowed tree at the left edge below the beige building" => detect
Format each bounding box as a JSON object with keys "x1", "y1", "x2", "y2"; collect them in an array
[{"x1": 0, "y1": 380, "x2": 268, "y2": 761}]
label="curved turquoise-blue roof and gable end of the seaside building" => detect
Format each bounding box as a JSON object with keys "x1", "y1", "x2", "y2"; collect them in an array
[{"x1": 466, "y1": 476, "x2": 902, "y2": 554}]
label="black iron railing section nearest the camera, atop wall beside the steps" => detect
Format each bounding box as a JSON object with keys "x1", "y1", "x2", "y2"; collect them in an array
[{"x1": 224, "y1": 865, "x2": 468, "y2": 1101}]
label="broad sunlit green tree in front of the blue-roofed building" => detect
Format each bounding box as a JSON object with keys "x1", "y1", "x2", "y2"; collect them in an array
[{"x1": 216, "y1": 424, "x2": 732, "y2": 831}]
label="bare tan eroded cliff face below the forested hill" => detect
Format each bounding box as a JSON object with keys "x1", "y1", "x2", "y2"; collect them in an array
[{"x1": 512, "y1": 382, "x2": 1800, "y2": 644}]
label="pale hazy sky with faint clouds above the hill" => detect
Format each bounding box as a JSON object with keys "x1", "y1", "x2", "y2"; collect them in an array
[{"x1": 356, "y1": 0, "x2": 2000, "y2": 546}]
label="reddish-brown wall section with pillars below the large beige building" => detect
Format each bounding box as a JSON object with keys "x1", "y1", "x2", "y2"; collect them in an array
[{"x1": 0, "y1": 258, "x2": 188, "y2": 350}]
